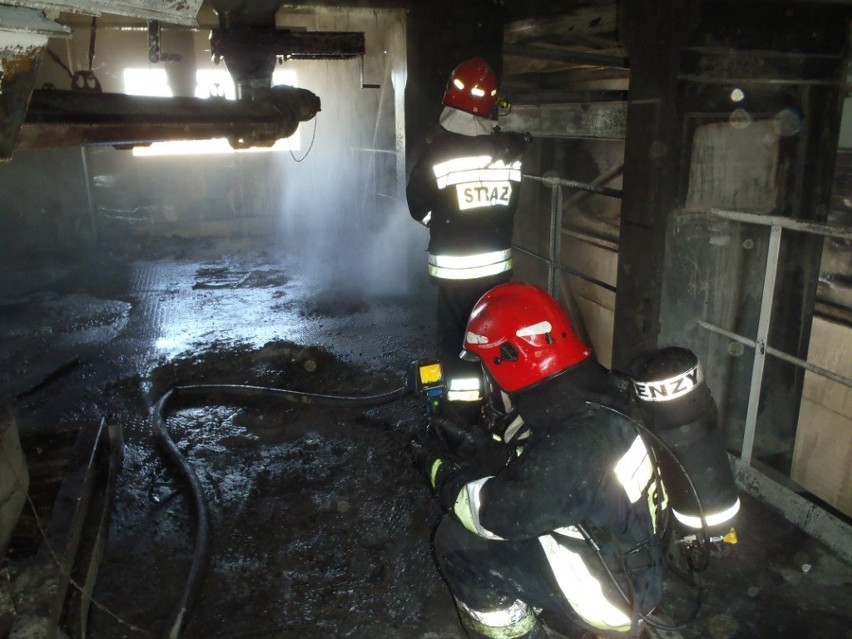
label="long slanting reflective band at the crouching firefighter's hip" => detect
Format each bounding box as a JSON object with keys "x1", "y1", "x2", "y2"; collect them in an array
[{"x1": 538, "y1": 535, "x2": 630, "y2": 632}]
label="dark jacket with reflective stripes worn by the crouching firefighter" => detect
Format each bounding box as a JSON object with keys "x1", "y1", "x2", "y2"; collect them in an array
[{"x1": 442, "y1": 360, "x2": 665, "y2": 631}]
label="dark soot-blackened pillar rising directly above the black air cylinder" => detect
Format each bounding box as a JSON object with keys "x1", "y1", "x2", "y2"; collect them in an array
[{"x1": 613, "y1": 0, "x2": 698, "y2": 368}]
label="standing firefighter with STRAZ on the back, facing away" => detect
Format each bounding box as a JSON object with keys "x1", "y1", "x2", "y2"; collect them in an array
[{"x1": 406, "y1": 58, "x2": 529, "y2": 421}]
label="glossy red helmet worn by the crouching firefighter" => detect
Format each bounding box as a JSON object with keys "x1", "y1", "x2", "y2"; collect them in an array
[{"x1": 463, "y1": 282, "x2": 592, "y2": 393}]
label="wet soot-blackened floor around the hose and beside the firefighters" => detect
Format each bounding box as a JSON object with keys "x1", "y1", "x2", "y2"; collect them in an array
[{"x1": 0, "y1": 242, "x2": 852, "y2": 639}]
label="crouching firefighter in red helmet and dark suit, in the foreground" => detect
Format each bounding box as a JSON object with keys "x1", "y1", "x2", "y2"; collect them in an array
[{"x1": 412, "y1": 283, "x2": 667, "y2": 639}]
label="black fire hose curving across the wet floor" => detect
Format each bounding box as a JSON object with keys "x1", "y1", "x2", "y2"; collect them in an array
[{"x1": 152, "y1": 384, "x2": 410, "y2": 639}]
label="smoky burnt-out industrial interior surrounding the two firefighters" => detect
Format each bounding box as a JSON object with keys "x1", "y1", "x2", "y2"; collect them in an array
[{"x1": 0, "y1": 0, "x2": 852, "y2": 639}]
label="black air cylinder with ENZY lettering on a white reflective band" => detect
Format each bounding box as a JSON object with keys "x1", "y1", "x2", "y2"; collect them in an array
[{"x1": 628, "y1": 347, "x2": 740, "y2": 532}]
